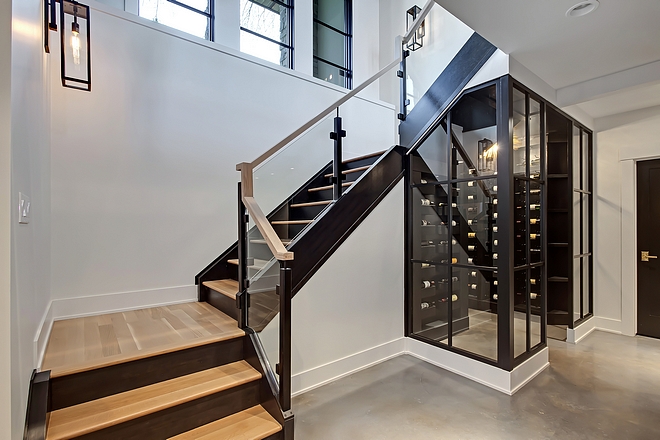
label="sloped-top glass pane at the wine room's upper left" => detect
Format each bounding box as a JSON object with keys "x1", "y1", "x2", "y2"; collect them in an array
[{"x1": 412, "y1": 120, "x2": 448, "y2": 183}]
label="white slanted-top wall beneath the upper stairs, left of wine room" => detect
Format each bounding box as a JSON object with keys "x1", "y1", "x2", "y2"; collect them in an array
[{"x1": 262, "y1": 181, "x2": 404, "y2": 394}]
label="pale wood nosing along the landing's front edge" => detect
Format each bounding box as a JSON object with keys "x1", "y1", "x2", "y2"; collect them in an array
[{"x1": 50, "y1": 324, "x2": 245, "y2": 379}]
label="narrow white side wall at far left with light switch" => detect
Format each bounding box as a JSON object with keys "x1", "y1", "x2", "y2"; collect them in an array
[{"x1": 11, "y1": 0, "x2": 56, "y2": 438}]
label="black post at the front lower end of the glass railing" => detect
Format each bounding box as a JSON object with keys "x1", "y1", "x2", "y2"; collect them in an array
[{"x1": 277, "y1": 260, "x2": 293, "y2": 413}]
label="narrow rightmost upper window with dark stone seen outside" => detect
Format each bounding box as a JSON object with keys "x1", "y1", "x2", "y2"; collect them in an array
[{"x1": 313, "y1": 0, "x2": 353, "y2": 89}]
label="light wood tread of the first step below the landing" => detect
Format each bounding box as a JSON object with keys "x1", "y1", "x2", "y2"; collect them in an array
[{"x1": 46, "y1": 360, "x2": 262, "y2": 440}]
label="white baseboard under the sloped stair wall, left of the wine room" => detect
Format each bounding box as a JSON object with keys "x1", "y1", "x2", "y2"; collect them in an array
[{"x1": 291, "y1": 338, "x2": 406, "y2": 396}]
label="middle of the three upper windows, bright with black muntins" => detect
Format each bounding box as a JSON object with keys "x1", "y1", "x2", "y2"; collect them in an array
[{"x1": 241, "y1": 0, "x2": 293, "y2": 69}]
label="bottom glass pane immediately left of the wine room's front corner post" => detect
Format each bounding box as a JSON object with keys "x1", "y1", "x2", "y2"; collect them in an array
[{"x1": 452, "y1": 267, "x2": 497, "y2": 360}]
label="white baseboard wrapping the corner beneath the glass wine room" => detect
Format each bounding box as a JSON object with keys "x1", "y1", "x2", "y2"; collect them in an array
[{"x1": 406, "y1": 338, "x2": 550, "y2": 395}]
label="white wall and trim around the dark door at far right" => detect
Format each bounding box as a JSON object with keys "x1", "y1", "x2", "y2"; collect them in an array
[{"x1": 594, "y1": 107, "x2": 660, "y2": 335}]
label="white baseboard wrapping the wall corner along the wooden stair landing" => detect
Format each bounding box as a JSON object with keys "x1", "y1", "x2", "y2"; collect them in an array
[{"x1": 33, "y1": 285, "x2": 197, "y2": 368}]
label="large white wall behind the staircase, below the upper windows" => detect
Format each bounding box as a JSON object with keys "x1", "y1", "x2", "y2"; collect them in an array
[{"x1": 51, "y1": 2, "x2": 395, "y2": 317}]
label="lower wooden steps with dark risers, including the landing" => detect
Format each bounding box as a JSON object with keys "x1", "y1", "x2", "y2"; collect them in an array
[{"x1": 32, "y1": 303, "x2": 285, "y2": 440}]
